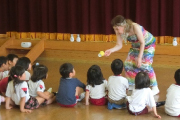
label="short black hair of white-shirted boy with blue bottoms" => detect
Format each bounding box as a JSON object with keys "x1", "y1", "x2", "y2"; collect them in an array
[{"x1": 111, "y1": 59, "x2": 123, "y2": 75}]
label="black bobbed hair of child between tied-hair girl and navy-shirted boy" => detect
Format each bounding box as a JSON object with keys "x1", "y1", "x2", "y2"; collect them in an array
[{"x1": 31, "y1": 65, "x2": 48, "y2": 82}]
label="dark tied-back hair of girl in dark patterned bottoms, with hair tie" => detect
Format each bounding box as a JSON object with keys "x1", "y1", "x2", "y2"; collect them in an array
[{"x1": 8, "y1": 65, "x2": 25, "y2": 93}]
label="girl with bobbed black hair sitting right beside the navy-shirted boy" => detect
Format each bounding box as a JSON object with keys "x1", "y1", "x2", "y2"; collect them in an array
[{"x1": 86, "y1": 65, "x2": 107, "y2": 105}]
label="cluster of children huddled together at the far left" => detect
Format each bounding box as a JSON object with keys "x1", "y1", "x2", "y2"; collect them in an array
[{"x1": 0, "y1": 54, "x2": 55, "y2": 112}]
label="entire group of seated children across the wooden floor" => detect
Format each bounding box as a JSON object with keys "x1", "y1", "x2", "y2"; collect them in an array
[{"x1": 0, "y1": 54, "x2": 180, "y2": 118}]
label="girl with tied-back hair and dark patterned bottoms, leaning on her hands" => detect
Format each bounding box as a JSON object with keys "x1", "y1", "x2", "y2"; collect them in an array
[{"x1": 6, "y1": 66, "x2": 45, "y2": 112}]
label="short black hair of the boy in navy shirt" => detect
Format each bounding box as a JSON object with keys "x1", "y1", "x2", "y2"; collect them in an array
[{"x1": 59, "y1": 63, "x2": 74, "y2": 78}]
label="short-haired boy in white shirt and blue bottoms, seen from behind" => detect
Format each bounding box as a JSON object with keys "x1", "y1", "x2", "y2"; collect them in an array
[{"x1": 108, "y1": 59, "x2": 129, "y2": 110}]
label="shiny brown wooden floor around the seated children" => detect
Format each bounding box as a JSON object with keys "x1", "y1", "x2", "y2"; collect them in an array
[{"x1": 0, "y1": 50, "x2": 180, "y2": 120}]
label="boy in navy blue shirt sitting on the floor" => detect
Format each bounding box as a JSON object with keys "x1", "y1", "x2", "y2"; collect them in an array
[{"x1": 56, "y1": 63, "x2": 86, "y2": 107}]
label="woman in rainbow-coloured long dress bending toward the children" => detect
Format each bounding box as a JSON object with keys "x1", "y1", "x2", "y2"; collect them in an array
[{"x1": 105, "y1": 15, "x2": 159, "y2": 95}]
